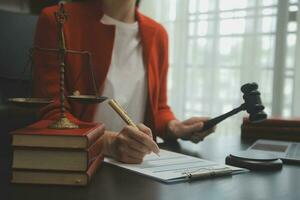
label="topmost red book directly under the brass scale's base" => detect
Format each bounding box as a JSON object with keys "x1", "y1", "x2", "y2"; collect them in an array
[{"x1": 11, "y1": 120, "x2": 104, "y2": 149}]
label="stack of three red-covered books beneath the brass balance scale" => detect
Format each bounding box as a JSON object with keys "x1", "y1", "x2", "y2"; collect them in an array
[{"x1": 11, "y1": 120, "x2": 104, "y2": 186}]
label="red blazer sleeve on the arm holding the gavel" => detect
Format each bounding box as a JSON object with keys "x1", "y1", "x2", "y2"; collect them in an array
[{"x1": 155, "y1": 28, "x2": 176, "y2": 137}]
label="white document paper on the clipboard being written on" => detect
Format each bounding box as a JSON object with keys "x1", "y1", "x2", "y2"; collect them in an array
[{"x1": 104, "y1": 149, "x2": 246, "y2": 182}]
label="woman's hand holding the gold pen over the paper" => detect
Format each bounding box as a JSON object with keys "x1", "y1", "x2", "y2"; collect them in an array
[{"x1": 103, "y1": 124, "x2": 159, "y2": 163}]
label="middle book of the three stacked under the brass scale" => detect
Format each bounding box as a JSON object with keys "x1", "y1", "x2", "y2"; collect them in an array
[{"x1": 12, "y1": 138, "x2": 101, "y2": 171}]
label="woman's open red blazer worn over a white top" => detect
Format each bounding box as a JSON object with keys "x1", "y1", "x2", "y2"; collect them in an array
[{"x1": 34, "y1": 0, "x2": 175, "y2": 137}]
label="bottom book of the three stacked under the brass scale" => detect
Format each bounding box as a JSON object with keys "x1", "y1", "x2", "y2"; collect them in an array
[{"x1": 11, "y1": 155, "x2": 103, "y2": 186}]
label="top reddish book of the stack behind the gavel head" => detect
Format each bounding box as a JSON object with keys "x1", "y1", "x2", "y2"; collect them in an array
[{"x1": 243, "y1": 117, "x2": 300, "y2": 128}]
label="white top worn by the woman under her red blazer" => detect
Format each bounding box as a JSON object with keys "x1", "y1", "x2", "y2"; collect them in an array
[{"x1": 94, "y1": 15, "x2": 147, "y2": 132}]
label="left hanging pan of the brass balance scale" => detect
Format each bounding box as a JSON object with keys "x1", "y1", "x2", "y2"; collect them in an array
[{"x1": 7, "y1": 98, "x2": 53, "y2": 107}]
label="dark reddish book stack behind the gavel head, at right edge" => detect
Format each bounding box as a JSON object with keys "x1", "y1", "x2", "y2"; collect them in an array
[{"x1": 241, "y1": 118, "x2": 300, "y2": 141}]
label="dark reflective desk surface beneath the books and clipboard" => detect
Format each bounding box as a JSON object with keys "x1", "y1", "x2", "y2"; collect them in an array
[{"x1": 0, "y1": 135, "x2": 300, "y2": 200}]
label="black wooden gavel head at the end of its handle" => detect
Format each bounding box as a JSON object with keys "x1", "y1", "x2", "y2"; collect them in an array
[{"x1": 241, "y1": 83, "x2": 267, "y2": 123}]
